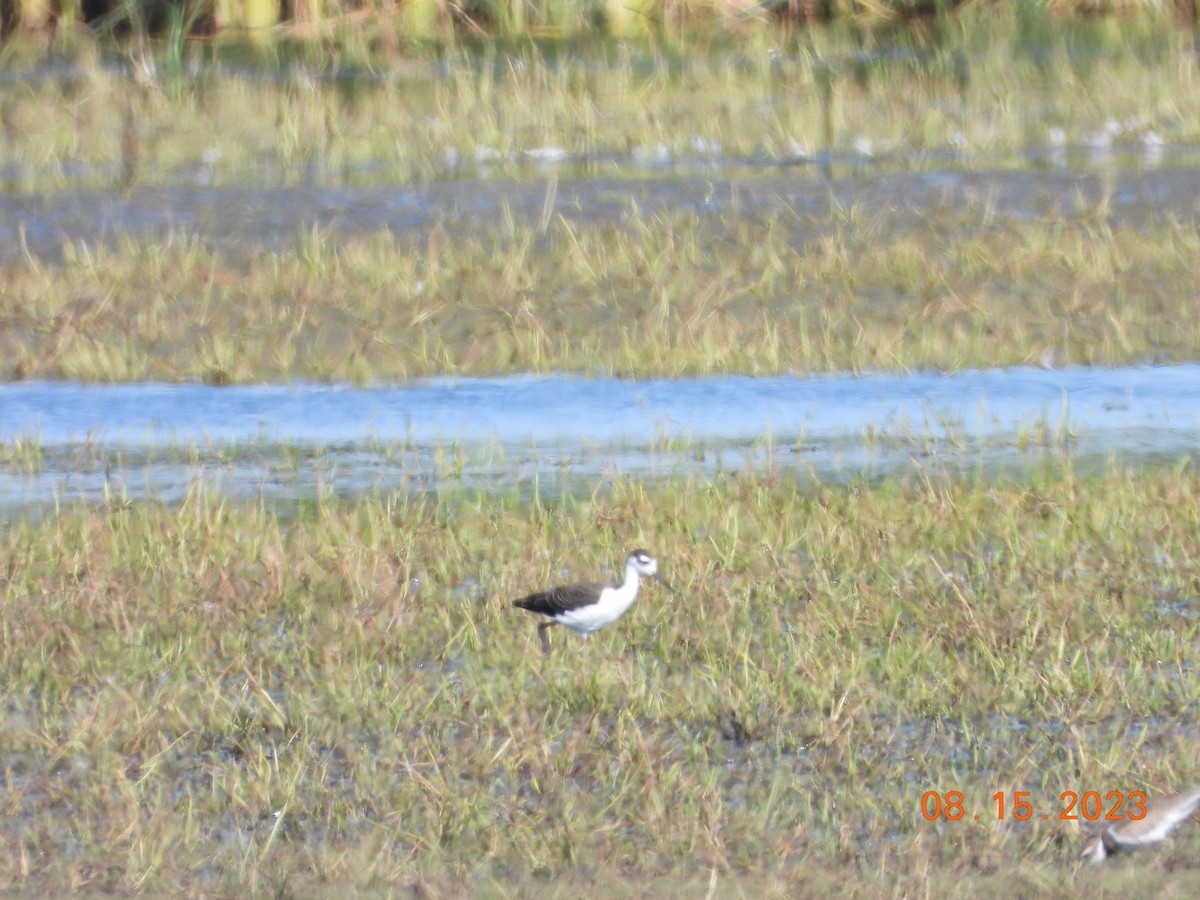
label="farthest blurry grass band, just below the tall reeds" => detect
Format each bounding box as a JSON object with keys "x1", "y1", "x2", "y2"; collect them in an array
[{"x1": 0, "y1": 4, "x2": 1200, "y2": 192}]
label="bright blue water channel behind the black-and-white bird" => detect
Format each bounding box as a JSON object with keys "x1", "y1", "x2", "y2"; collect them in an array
[{"x1": 0, "y1": 365, "x2": 1200, "y2": 517}]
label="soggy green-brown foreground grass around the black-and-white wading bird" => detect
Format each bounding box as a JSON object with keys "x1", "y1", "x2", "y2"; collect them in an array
[{"x1": 7, "y1": 468, "x2": 1200, "y2": 896}]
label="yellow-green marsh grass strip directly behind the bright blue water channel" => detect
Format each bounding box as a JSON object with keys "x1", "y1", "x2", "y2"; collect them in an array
[{"x1": 0, "y1": 196, "x2": 1200, "y2": 384}]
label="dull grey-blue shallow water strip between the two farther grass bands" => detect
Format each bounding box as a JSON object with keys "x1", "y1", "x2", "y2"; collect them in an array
[{"x1": 0, "y1": 164, "x2": 1200, "y2": 264}]
